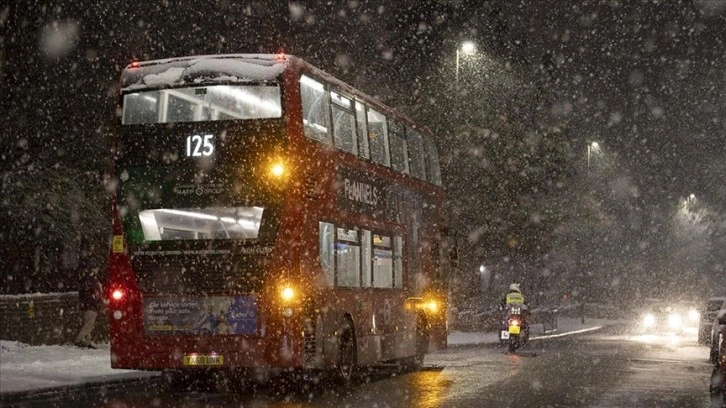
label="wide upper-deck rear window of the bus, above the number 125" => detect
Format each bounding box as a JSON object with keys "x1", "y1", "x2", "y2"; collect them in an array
[{"x1": 121, "y1": 85, "x2": 282, "y2": 125}]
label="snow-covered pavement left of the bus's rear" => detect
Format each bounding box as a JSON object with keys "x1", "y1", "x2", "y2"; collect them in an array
[{"x1": 0, "y1": 340, "x2": 158, "y2": 394}]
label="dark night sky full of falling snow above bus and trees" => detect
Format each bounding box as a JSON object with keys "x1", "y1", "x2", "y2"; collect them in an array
[{"x1": 0, "y1": 0, "x2": 726, "y2": 298}]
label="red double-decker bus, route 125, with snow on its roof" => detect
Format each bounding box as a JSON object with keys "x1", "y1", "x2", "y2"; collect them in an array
[{"x1": 109, "y1": 54, "x2": 450, "y2": 380}]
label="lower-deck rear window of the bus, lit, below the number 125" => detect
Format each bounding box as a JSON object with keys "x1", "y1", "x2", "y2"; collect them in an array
[{"x1": 139, "y1": 207, "x2": 264, "y2": 241}]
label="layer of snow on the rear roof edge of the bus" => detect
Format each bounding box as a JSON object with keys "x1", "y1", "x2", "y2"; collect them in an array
[{"x1": 121, "y1": 54, "x2": 286, "y2": 92}]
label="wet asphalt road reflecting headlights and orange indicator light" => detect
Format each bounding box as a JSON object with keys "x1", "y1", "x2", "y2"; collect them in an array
[{"x1": 5, "y1": 328, "x2": 724, "y2": 408}]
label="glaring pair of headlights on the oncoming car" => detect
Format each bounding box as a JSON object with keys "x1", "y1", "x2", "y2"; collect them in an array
[{"x1": 638, "y1": 301, "x2": 700, "y2": 334}]
